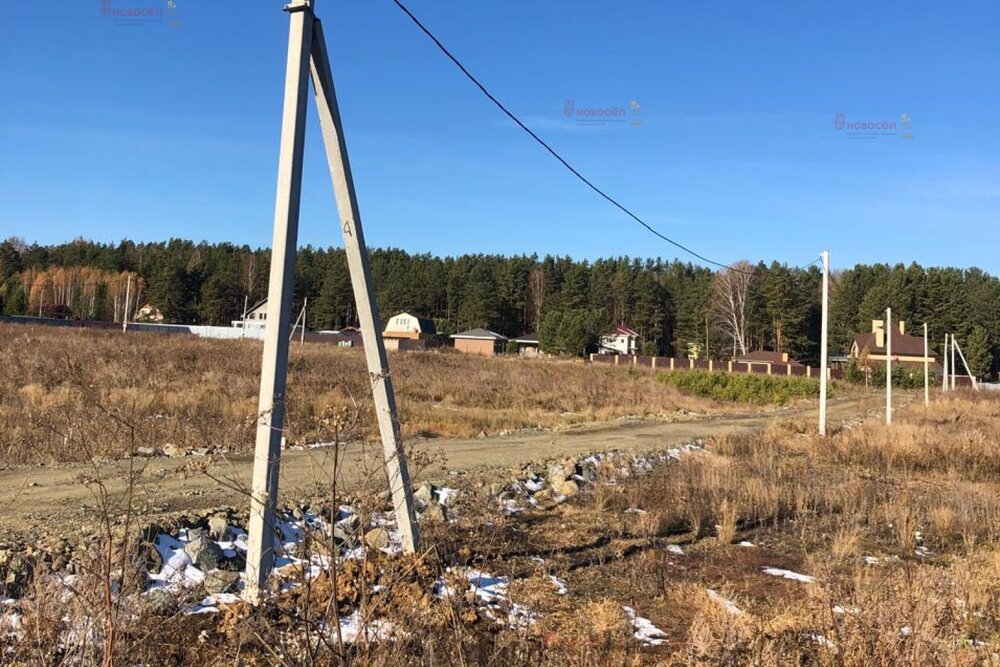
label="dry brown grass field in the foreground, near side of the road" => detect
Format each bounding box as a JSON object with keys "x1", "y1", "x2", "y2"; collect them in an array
[{"x1": 3, "y1": 393, "x2": 1000, "y2": 667}]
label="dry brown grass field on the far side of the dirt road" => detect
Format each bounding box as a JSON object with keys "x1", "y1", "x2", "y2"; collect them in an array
[{"x1": 0, "y1": 325, "x2": 733, "y2": 465}]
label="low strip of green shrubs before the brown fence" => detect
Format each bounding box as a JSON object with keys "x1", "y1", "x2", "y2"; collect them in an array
[{"x1": 657, "y1": 371, "x2": 820, "y2": 405}]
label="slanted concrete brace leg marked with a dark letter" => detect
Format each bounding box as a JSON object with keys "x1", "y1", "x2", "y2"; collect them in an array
[{"x1": 310, "y1": 20, "x2": 420, "y2": 553}]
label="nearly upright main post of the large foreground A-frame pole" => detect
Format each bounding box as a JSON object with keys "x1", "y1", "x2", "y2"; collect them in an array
[{"x1": 245, "y1": 0, "x2": 313, "y2": 603}]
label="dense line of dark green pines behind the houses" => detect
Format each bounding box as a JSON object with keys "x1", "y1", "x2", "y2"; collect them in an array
[{"x1": 0, "y1": 239, "x2": 1000, "y2": 375}]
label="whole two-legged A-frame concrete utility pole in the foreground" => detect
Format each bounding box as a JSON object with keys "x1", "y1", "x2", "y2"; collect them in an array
[{"x1": 245, "y1": 0, "x2": 419, "y2": 604}]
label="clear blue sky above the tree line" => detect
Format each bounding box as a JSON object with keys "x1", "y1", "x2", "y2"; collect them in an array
[{"x1": 0, "y1": 0, "x2": 1000, "y2": 273}]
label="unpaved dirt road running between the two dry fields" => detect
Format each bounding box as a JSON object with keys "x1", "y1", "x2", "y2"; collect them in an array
[{"x1": 0, "y1": 395, "x2": 882, "y2": 533}]
